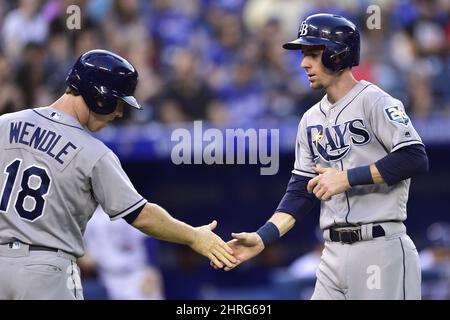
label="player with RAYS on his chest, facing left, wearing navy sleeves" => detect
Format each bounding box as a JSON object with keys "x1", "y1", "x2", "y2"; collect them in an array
[{"x1": 220, "y1": 14, "x2": 428, "y2": 299}]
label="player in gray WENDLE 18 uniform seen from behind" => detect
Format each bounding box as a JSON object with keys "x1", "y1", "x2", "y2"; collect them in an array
[{"x1": 0, "y1": 50, "x2": 235, "y2": 299}]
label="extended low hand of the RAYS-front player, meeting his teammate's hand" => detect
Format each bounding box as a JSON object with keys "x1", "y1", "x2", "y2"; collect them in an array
[{"x1": 211, "y1": 232, "x2": 264, "y2": 271}]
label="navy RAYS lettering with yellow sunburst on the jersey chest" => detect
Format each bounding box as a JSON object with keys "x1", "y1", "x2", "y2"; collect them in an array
[{"x1": 306, "y1": 119, "x2": 370, "y2": 161}]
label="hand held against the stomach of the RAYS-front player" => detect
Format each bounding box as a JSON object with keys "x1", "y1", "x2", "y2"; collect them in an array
[{"x1": 307, "y1": 167, "x2": 350, "y2": 201}]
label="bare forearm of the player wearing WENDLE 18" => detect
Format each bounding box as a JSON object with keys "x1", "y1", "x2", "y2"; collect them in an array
[{"x1": 133, "y1": 203, "x2": 195, "y2": 245}]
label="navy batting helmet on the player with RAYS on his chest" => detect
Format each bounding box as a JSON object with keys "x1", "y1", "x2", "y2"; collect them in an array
[{"x1": 283, "y1": 13, "x2": 360, "y2": 71}]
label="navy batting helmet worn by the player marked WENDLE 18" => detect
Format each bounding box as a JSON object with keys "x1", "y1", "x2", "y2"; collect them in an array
[{"x1": 66, "y1": 50, "x2": 142, "y2": 114}]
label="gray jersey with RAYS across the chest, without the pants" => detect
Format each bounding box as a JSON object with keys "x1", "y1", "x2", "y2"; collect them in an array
[{"x1": 292, "y1": 81, "x2": 422, "y2": 229}]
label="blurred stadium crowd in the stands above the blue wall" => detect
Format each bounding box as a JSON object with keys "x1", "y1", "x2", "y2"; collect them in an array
[{"x1": 0, "y1": 0, "x2": 450, "y2": 124}]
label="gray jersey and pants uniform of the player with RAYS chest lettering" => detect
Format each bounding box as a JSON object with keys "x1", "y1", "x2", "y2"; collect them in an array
[{"x1": 293, "y1": 81, "x2": 422, "y2": 299}]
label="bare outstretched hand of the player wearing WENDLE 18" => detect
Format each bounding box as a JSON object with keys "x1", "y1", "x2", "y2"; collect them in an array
[{"x1": 191, "y1": 220, "x2": 237, "y2": 269}]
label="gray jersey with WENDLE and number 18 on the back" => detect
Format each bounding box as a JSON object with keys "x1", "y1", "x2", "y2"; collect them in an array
[{"x1": 0, "y1": 107, "x2": 146, "y2": 256}]
